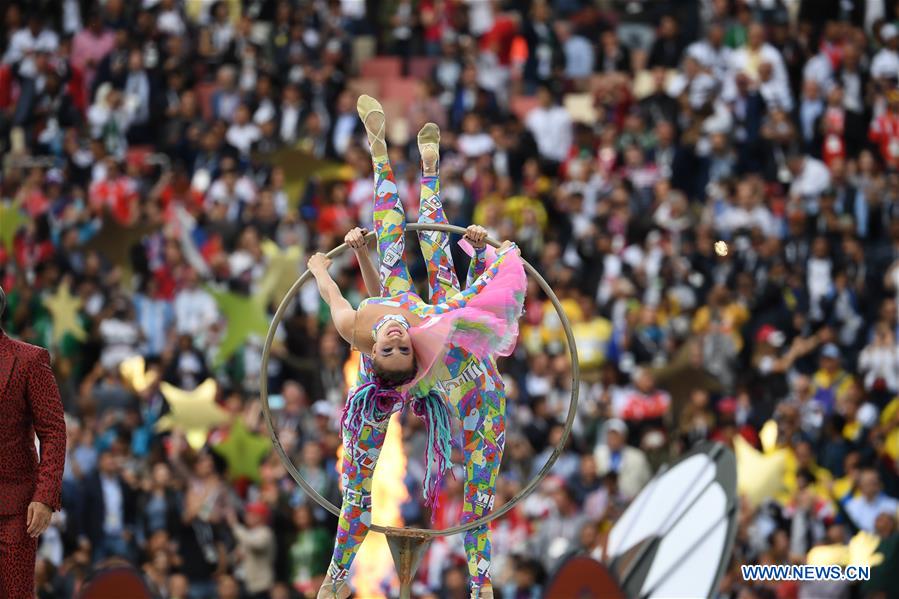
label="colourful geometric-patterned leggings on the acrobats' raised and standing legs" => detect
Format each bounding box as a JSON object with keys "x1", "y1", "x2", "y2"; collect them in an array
[{"x1": 328, "y1": 162, "x2": 506, "y2": 589}]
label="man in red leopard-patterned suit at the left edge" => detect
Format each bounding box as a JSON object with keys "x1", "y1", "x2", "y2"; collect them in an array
[{"x1": 0, "y1": 288, "x2": 66, "y2": 599}]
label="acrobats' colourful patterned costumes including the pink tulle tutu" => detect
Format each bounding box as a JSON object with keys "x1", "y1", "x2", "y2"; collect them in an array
[{"x1": 328, "y1": 156, "x2": 525, "y2": 589}]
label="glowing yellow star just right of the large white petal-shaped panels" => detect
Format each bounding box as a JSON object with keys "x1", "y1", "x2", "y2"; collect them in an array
[{"x1": 734, "y1": 424, "x2": 787, "y2": 506}]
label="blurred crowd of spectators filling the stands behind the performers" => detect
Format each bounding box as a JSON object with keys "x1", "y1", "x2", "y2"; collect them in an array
[{"x1": 0, "y1": 0, "x2": 899, "y2": 599}]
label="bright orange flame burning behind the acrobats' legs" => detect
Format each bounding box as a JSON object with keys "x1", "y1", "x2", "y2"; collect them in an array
[{"x1": 337, "y1": 352, "x2": 409, "y2": 599}]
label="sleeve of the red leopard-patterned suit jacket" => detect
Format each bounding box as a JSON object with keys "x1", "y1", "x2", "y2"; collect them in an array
[{"x1": 28, "y1": 349, "x2": 66, "y2": 511}]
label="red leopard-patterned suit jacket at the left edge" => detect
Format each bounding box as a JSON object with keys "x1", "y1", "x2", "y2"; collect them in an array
[{"x1": 0, "y1": 330, "x2": 66, "y2": 516}]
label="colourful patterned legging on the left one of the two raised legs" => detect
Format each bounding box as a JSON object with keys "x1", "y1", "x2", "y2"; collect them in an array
[{"x1": 372, "y1": 161, "x2": 412, "y2": 297}]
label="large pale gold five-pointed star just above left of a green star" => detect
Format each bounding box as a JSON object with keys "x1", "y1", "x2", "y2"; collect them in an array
[{"x1": 156, "y1": 379, "x2": 228, "y2": 450}]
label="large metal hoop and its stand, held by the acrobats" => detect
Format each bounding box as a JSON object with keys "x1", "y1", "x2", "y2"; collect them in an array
[{"x1": 259, "y1": 223, "x2": 580, "y2": 597}]
